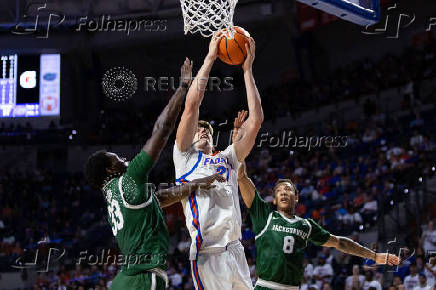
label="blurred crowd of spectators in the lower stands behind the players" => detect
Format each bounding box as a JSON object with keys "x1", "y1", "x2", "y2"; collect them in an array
[{"x1": 0, "y1": 99, "x2": 436, "y2": 290}]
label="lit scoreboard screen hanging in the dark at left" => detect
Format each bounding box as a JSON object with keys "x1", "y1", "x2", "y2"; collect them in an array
[{"x1": 0, "y1": 54, "x2": 61, "y2": 118}]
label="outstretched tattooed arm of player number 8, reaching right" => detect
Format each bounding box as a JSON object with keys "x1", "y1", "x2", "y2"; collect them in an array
[{"x1": 322, "y1": 235, "x2": 400, "y2": 266}]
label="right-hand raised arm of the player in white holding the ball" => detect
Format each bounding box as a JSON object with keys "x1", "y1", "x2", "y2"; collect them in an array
[{"x1": 234, "y1": 38, "x2": 263, "y2": 161}]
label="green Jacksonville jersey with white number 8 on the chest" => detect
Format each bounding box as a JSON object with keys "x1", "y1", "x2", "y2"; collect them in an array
[{"x1": 250, "y1": 192, "x2": 330, "y2": 286}]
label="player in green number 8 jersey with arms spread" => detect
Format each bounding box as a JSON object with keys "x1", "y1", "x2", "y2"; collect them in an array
[{"x1": 238, "y1": 163, "x2": 400, "y2": 290}]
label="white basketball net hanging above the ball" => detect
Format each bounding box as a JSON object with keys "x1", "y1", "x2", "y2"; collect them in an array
[{"x1": 180, "y1": 0, "x2": 238, "y2": 37}]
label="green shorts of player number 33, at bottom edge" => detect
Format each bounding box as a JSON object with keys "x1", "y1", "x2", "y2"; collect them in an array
[{"x1": 110, "y1": 272, "x2": 165, "y2": 290}]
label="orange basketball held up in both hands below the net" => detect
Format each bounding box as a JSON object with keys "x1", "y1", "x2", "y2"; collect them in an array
[{"x1": 218, "y1": 26, "x2": 250, "y2": 65}]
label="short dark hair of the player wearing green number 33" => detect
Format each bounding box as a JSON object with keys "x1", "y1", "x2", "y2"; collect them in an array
[{"x1": 85, "y1": 150, "x2": 112, "y2": 189}]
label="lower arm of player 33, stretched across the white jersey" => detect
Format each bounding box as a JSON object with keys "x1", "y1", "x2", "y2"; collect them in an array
[{"x1": 156, "y1": 173, "x2": 225, "y2": 208}]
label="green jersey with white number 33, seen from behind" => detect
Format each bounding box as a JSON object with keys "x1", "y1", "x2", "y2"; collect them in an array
[{"x1": 103, "y1": 151, "x2": 168, "y2": 275}]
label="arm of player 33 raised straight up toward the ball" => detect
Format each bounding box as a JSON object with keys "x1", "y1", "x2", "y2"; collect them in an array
[{"x1": 143, "y1": 58, "x2": 192, "y2": 161}]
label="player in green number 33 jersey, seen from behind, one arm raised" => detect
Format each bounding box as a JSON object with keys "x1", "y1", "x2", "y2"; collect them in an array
[{"x1": 85, "y1": 59, "x2": 223, "y2": 290}]
